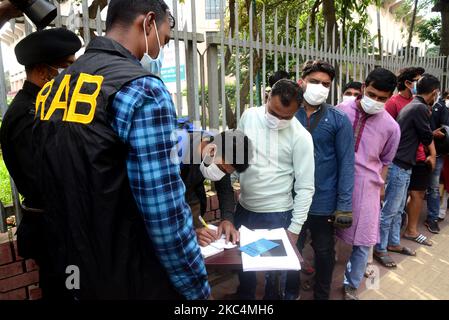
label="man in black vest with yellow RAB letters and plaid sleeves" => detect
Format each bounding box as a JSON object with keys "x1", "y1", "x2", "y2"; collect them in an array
[{"x1": 33, "y1": 0, "x2": 210, "y2": 299}]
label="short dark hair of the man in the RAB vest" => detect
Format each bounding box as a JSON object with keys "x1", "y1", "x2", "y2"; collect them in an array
[{"x1": 106, "y1": 0, "x2": 169, "y2": 31}]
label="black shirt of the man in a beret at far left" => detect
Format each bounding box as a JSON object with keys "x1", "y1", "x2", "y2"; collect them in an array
[{"x1": 0, "y1": 81, "x2": 42, "y2": 208}]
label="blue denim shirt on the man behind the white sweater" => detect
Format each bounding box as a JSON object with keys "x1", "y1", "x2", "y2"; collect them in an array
[{"x1": 296, "y1": 105, "x2": 354, "y2": 215}]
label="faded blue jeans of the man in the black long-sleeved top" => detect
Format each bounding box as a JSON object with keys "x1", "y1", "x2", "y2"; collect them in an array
[{"x1": 375, "y1": 163, "x2": 412, "y2": 252}]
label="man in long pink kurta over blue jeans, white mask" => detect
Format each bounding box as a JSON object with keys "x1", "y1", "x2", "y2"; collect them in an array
[{"x1": 337, "y1": 68, "x2": 401, "y2": 300}]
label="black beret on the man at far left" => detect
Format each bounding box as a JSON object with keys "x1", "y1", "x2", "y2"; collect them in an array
[{"x1": 14, "y1": 28, "x2": 81, "y2": 66}]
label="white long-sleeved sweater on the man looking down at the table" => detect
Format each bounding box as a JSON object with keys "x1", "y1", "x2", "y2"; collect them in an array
[{"x1": 238, "y1": 107, "x2": 315, "y2": 234}]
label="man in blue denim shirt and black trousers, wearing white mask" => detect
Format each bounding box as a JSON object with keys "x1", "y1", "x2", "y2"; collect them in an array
[{"x1": 285, "y1": 60, "x2": 354, "y2": 300}]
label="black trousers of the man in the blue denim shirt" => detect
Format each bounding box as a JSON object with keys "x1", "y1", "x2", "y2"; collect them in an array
[{"x1": 285, "y1": 214, "x2": 335, "y2": 300}]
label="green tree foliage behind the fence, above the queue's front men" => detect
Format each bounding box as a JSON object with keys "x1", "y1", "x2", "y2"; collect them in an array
[{"x1": 219, "y1": 0, "x2": 376, "y2": 128}]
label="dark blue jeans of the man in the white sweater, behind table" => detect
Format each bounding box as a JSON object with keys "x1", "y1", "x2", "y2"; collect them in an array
[{"x1": 234, "y1": 204, "x2": 292, "y2": 300}]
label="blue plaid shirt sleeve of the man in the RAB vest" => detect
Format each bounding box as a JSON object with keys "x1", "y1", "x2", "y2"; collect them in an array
[{"x1": 110, "y1": 77, "x2": 210, "y2": 300}]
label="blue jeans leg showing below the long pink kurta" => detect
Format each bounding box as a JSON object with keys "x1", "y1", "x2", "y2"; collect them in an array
[{"x1": 343, "y1": 246, "x2": 370, "y2": 289}]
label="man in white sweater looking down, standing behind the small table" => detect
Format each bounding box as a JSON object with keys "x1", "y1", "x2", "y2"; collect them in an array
[{"x1": 234, "y1": 79, "x2": 315, "y2": 299}]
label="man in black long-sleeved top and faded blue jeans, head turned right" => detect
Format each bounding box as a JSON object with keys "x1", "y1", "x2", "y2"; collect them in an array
[{"x1": 374, "y1": 74, "x2": 440, "y2": 268}]
